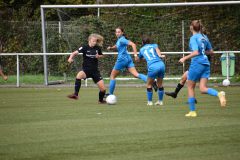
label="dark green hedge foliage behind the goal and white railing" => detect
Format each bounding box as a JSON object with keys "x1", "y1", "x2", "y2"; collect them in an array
[{"x1": 0, "y1": 0, "x2": 240, "y2": 76}]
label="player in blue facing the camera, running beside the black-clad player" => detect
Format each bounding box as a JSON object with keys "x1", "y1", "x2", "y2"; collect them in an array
[{"x1": 107, "y1": 27, "x2": 157, "y2": 94}]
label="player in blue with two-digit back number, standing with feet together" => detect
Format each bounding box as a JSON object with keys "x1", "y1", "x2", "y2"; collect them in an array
[{"x1": 138, "y1": 36, "x2": 165, "y2": 106}]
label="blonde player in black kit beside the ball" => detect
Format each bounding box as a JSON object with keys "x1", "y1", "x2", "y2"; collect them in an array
[{"x1": 68, "y1": 34, "x2": 106, "y2": 104}]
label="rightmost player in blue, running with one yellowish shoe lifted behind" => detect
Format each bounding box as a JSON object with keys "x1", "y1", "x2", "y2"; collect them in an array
[{"x1": 179, "y1": 20, "x2": 226, "y2": 117}]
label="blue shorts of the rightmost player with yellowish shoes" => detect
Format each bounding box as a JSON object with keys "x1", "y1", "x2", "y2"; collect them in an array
[{"x1": 187, "y1": 64, "x2": 210, "y2": 82}]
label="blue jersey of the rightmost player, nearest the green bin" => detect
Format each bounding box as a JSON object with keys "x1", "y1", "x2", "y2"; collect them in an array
[{"x1": 189, "y1": 33, "x2": 212, "y2": 65}]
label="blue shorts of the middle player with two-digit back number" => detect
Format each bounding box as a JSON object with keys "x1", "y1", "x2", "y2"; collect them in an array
[{"x1": 147, "y1": 61, "x2": 165, "y2": 79}]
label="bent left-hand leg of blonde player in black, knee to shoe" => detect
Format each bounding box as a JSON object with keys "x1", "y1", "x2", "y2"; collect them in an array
[{"x1": 68, "y1": 71, "x2": 87, "y2": 99}]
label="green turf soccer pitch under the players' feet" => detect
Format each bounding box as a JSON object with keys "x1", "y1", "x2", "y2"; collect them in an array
[{"x1": 0, "y1": 87, "x2": 240, "y2": 160}]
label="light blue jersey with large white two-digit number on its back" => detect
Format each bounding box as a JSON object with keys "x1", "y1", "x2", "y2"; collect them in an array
[{"x1": 138, "y1": 44, "x2": 162, "y2": 67}]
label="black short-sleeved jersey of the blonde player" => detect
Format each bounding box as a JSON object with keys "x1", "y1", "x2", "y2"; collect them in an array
[{"x1": 78, "y1": 45, "x2": 102, "y2": 70}]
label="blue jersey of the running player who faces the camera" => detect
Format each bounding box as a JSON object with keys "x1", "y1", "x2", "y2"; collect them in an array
[{"x1": 116, "y1": 36, "x2": 131, "y2": 61}]
